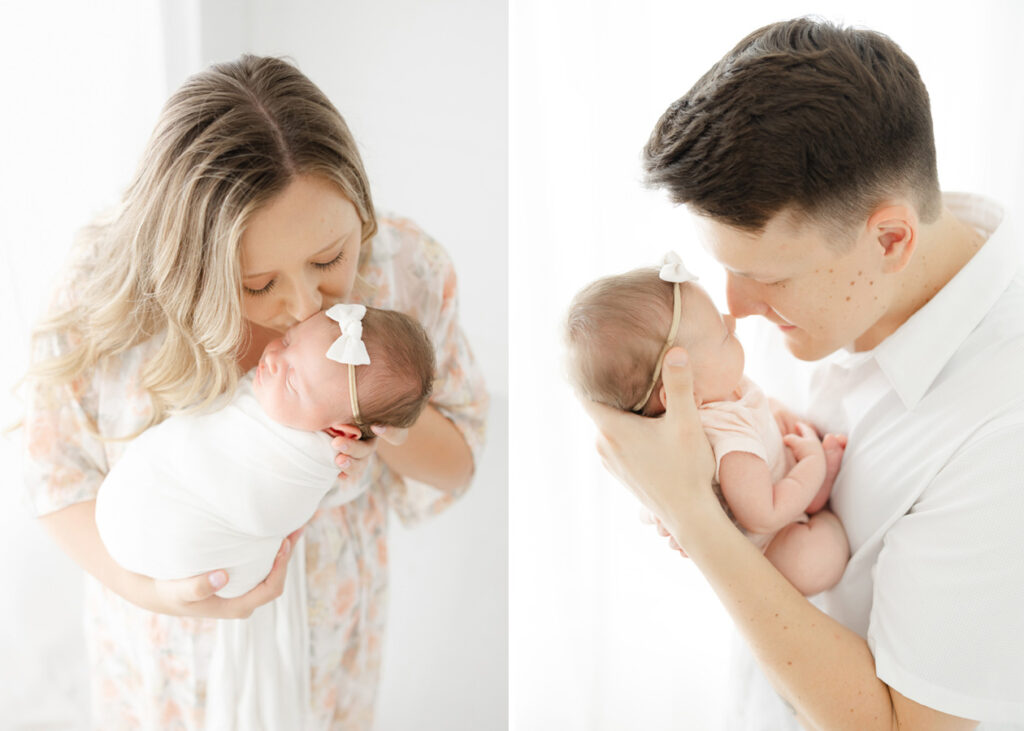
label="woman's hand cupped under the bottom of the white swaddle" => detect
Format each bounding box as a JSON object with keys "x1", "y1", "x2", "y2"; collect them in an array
[{"x1": 146, "y1": 528, "x2": 302, "y2": 619}]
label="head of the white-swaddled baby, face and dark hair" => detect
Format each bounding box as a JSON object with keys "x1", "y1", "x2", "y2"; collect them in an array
[{"x1": 253, "y1": 307, "x2": 434, "y2": 438}]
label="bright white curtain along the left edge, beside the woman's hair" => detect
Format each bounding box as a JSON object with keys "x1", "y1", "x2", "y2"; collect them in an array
[{"x1": 0, "y1": 0, "x2": 166, "y2": 729}]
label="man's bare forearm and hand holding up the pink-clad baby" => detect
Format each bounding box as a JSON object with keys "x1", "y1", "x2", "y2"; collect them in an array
[{"x1": 587, "y1": 348, "x2": 977, "y2": 731}]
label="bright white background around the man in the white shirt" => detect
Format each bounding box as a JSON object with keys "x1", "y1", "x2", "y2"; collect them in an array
[{"x1": 509, "y1": 0, "x2": 1024, "y2": 731}]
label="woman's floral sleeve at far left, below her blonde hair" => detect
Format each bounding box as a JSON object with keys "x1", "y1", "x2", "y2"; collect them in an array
[{"x1": 23, "y1": 329, "x2": 106, "y2": 517}]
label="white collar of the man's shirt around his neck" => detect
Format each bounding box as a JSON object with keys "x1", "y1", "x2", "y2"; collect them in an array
[{"x1": 864, "y1": 194, "x2": 1020, "y2": 409}]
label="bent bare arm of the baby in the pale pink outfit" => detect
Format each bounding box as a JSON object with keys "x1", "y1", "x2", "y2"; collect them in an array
[{"x1": 719, "y1": 417, "x2": 825, "y2": 533}]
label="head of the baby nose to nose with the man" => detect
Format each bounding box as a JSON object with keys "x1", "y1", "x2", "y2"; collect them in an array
[{"x1": 565, "y1": 267, "x2": 743, "y2": 416}]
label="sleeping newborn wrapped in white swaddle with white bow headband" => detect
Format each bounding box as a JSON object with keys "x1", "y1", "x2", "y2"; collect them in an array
[{"x1": 96, "y1": 305, "x2": 434, "y2": 598}]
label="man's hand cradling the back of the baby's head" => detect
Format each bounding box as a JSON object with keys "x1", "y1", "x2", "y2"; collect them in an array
[{"x1": 584, "y1": 348, "x2": 717, "y2": 545}]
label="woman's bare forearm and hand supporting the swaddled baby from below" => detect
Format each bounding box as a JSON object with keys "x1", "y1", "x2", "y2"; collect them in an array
[{"x1": 38, "y1": 500, "x2": 301, "y2": 618}]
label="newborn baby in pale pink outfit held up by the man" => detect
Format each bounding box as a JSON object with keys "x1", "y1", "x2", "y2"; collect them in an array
[{"x1": 566, "y1": 254, "x2": 849, "y2": 596}]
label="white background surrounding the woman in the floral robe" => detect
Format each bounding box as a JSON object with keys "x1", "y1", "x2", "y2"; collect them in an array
[{"x1": 0, "y1": 0, "x2": 508, "y2": 731}]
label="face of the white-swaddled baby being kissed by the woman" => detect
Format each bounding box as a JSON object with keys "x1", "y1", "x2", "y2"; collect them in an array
[{"x1": 253, "y1": 312, "x2": 352, "y2": 431}]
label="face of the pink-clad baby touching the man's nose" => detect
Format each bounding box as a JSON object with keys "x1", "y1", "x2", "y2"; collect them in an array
[{"x1": 677, "y1": 285, "x2": 743, "y2": 403}]
